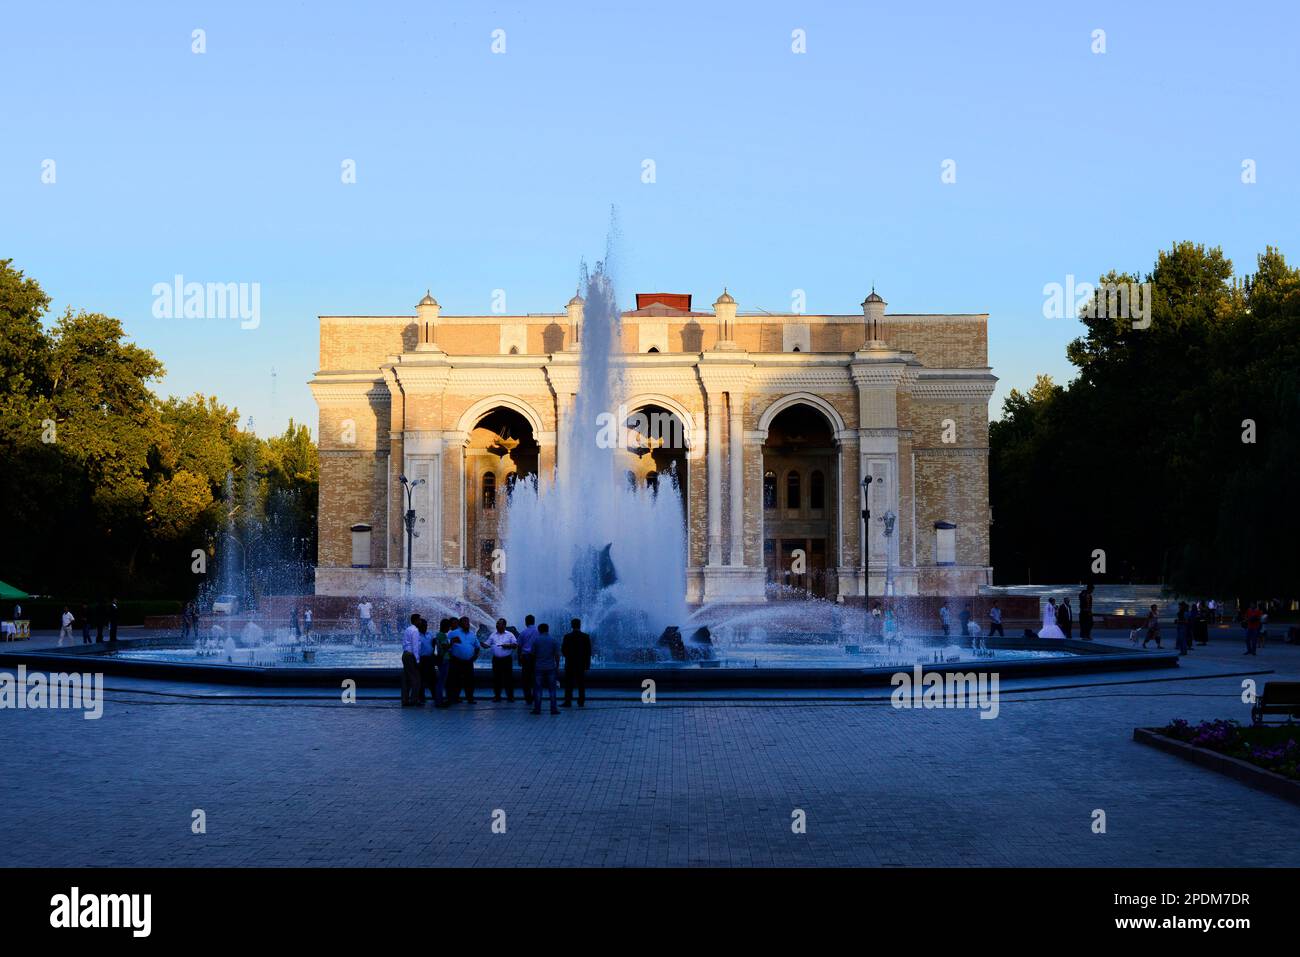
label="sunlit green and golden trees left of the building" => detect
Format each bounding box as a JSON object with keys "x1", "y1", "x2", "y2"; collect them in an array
[{"x1": 0, "y1": 260, "x2": 319, "y2": 598}]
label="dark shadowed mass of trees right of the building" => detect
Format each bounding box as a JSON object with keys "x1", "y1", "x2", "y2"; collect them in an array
[{"x1": 989, "y1": 242, "x2": 1300, "y2": 597}]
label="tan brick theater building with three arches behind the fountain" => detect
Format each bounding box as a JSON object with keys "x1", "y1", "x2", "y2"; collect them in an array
[{"x1": 311, "y1": 291, "x2": 996, "y2": 602}]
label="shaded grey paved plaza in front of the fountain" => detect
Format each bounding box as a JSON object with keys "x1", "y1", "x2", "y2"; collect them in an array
[{"x1": 0, "y1": 629, "x2": 1300, "y2": 866}]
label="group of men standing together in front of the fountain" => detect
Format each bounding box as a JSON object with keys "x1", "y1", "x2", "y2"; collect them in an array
[{"x1": 402, "y1": 614, "x2": 592, "y2": 714}]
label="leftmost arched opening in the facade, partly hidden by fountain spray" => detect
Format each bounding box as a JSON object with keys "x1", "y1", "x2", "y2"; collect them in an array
[{"x1": 465, "y1": 406, "x2": 540, "y2": 579}]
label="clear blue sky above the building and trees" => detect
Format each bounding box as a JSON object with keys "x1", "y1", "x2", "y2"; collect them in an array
[{"x1": 0, "y1": 0, "x2": 1300, "y2": 433}]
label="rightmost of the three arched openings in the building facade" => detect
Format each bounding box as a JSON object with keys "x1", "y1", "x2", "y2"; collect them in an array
[{"x1": 763, "y1": 402, "x2": 839, "y2": 598}]
